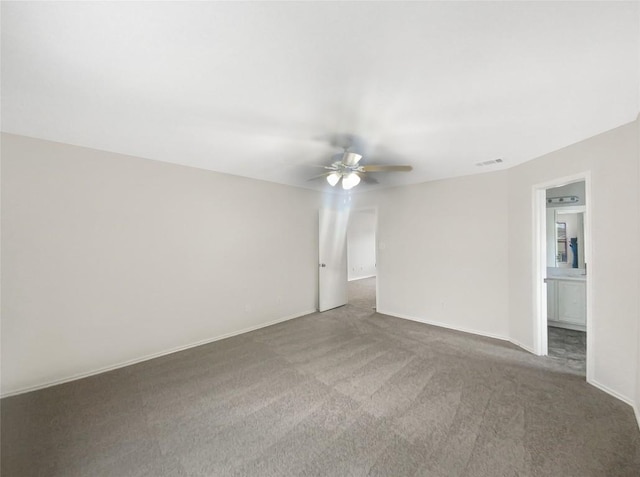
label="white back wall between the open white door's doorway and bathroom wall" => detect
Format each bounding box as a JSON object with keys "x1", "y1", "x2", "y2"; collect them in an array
[{"x1": 356, "y1": 171, "x2": 508, "y2": 338}]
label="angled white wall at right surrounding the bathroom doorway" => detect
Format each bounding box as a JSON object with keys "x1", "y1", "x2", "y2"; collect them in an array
[{"x1": 508, "y1": 122, "x2": 640, "y2": 402}]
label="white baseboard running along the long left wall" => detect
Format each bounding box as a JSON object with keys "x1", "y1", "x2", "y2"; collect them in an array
[{"x1": 0, "y1": 310, "x2": 317, "y2": 398}]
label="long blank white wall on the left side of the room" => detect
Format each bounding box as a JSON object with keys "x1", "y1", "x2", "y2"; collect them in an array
[{"x1": 2, "y1": 135, "x2": 320, "y2": 394}]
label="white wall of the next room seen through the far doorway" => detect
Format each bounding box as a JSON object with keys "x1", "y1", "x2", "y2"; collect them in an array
[{"x1": 347, "y1": 210, "x2": 376, "y2": 280}]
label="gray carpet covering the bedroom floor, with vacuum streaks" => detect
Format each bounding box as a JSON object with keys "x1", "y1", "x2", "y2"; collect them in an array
[{"x1": 1, "y1": 283, "x2": 640, "y2": 477}]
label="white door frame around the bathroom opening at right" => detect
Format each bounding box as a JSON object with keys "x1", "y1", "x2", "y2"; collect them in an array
[{"x1": 532, "y1": 170, "x2": 597, "y2": 382}]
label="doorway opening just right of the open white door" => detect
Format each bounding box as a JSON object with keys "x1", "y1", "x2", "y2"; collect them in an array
[{"x1": 347, "y1": 208, "x2": 377, "y2": 312}]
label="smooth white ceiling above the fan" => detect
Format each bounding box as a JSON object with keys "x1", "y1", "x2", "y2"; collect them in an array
[{"x1": 1, "y1": 1, "x2": 640, "y2": 190}]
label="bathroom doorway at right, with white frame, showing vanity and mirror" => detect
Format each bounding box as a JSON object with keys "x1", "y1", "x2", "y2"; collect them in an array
[{"x1": 534, "y1": 172, "x2": 593, "y2": 381}]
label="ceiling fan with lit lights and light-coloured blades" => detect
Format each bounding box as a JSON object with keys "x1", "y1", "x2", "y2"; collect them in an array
[{"x1": 309, "y1": 147, "x2": 413, "y2": 190}]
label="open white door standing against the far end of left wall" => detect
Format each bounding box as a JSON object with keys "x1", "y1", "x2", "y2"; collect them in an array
[{"x1": 318, "y1": 209, "x2": 349, "y2": 311}]
